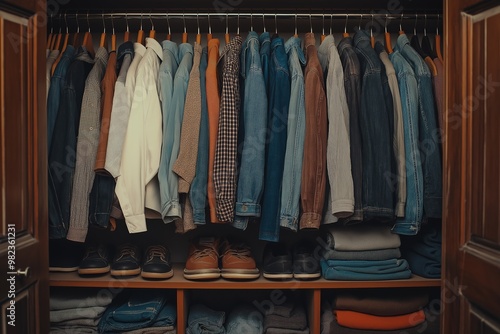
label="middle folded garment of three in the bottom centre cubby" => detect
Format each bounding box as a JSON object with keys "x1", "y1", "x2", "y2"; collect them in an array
[{"x1": 226, "y1": 304, "x2": 264, "y2": 334}]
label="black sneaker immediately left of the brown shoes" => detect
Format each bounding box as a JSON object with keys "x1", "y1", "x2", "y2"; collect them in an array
[{"x1": 141, "y1": 245, "x2": 174, "y2": 279}]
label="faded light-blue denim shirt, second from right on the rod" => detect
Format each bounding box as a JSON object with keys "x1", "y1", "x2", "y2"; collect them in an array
[{"x1": 389, "y1": 49, "x2": 424, "y2": 234}]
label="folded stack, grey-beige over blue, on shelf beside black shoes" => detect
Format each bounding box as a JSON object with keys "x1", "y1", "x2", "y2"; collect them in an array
[{"x1": 320, "y1": 225, "x2": 411, "y2": 280}]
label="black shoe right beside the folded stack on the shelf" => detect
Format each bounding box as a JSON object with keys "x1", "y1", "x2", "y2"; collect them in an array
[{"x1": 293, "y1": 241, "x2": 321, "y2": 279}]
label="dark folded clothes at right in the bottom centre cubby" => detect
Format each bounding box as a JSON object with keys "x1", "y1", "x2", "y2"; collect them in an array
[{"x1": 264, "y1": 302, "x2": 309, "y2": 334}]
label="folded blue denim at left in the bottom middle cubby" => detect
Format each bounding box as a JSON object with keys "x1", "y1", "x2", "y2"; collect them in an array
[{"x1": 186, "y1": 304, "x2": 226, "y2": 334}]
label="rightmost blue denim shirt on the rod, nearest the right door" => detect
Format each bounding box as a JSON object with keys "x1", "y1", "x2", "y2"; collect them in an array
[{"x1": 396, "y1": 35, "x2": 442, "y2": 222}]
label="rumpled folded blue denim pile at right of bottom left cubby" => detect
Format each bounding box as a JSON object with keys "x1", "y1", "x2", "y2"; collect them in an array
[{"x1": 97, "y1": 290, "x2": 177, "y2": 334}]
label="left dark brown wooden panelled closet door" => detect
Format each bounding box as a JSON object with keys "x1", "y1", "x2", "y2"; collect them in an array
[{"x1": 0, "y1": 0, "x2": 49, "y2": 333}]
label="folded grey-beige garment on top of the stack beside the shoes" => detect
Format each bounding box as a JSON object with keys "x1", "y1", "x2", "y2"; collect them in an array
[{"x1": 326, "y1": 224, "x2": 401, "y2": 251}]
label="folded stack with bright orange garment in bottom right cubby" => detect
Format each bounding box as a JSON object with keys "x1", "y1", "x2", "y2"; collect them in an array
[{"x1": 321, "y1": 290, "x2": 439, "y2": 334}]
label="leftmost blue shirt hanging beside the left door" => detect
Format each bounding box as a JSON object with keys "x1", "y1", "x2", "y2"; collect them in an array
[{"x1": 47, "y1": 45, "x2": 75, "y2": 149}]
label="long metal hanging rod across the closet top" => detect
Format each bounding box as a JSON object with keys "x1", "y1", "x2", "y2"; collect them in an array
[{"x1": 61, "y1": 11, "x2": 442, "y2": 20}]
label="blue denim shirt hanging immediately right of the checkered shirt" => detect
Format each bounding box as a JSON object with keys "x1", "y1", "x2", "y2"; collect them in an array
[{"x1": 233, "y1": 31, "x2": 267, "y2": 229}]
